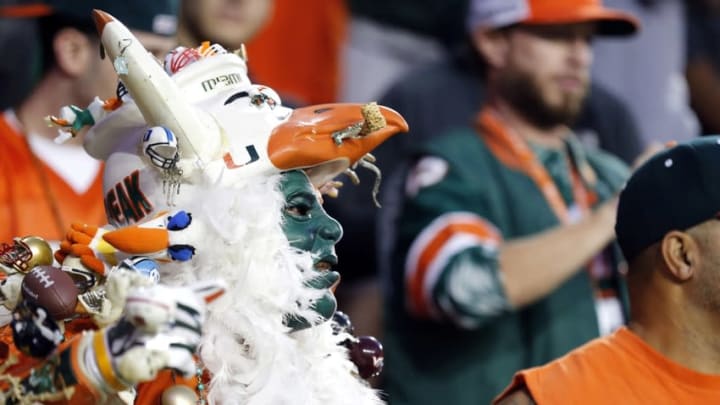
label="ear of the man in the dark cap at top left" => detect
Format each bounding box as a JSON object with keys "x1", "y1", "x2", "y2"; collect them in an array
[{"x1": 52, "y1": 27, "x2": 97, "y2": 77}]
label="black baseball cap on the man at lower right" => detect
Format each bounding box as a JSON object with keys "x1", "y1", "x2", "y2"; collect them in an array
[{"x1": 615, "y1": 136, "x2": 720, "y2": 261}]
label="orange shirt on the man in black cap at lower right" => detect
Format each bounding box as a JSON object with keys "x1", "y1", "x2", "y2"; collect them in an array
[{"x1": 493, "y1": 327, "x2": 720, "y2": 405}]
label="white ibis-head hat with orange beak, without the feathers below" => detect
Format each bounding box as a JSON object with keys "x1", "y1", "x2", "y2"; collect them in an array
[{"x1": 86, "y1": 10, "x2": 407, "y2": 191}]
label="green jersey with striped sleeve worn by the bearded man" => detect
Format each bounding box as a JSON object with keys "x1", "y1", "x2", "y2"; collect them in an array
[{"x1": 384, "y1": 118, "x2": 629, "y2": 405}]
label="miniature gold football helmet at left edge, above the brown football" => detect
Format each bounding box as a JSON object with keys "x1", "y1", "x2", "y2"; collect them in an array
[{"x1": 0, "y1": 236, "x2": 53, "y2": 273}]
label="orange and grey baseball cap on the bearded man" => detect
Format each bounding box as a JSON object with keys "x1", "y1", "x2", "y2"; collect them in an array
[{"x1": 467, "y1": 0, "x2": 640, "y2": 36}]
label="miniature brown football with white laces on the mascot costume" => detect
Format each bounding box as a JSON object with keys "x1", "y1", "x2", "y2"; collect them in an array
[{"x1": 21, "y1": 266, "x2": 78, "y2": 320}]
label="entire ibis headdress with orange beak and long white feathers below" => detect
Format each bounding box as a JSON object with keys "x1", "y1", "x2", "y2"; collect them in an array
[{"x1": 31, "y1": 10, "x2": 407, "y2": 405}]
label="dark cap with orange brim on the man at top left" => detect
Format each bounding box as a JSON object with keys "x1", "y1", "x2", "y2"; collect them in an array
[{"x1": 0, "y1": 0, "x2": 178, "y2": 36}]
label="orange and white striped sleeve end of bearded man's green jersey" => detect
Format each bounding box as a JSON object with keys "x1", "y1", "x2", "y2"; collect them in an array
[{"x1": 404, "y1": 211, "x2": 510, "y2": 328}]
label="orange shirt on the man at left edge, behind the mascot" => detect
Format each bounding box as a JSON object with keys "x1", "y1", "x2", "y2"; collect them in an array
[{"x1": 0, "y1": 114, "x2": 107, "y2": 243}]
